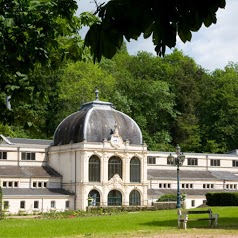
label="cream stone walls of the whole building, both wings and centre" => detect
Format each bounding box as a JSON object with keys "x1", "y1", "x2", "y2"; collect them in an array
[{"x1": 0, "y1": 134, "x2": 238, "y2": 214}]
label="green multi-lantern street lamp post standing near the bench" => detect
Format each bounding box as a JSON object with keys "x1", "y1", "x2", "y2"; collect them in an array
[{"x1": 167, "y1": 145, "x2": 185, "y2": 208}]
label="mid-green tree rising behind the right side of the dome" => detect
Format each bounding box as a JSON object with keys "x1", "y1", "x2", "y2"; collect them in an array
[{"x1": 100, "y1": 51, "x2": 176, "y2": 150}]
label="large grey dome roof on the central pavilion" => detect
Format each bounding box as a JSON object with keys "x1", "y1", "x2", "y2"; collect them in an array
[{"x1": 54, "y1": 100, "x2": 142, "y2": 146}]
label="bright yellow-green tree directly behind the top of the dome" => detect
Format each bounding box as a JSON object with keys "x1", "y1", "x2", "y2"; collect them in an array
[{"x1": 54, "y1": 61, "x2": 115, "y2": 123}]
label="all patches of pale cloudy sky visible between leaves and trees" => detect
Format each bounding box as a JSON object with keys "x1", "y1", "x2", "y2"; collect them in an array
[{"x1": 78, "y1": 0, "x2": 238, "y2": 71}]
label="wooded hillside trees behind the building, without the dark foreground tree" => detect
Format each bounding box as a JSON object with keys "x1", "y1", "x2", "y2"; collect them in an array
[{"x1": 0, "y1": 46, "x2": 238, "y2": 153}]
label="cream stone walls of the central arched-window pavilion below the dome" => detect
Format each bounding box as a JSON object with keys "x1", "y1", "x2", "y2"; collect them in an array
[{"x1": 49, "y1": 131, "x2": 148, "y2": 210}]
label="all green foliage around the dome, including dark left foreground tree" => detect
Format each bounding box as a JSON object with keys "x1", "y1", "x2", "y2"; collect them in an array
[{"x1": 0, "y1": 0, "x2": 238, "y2": 153}]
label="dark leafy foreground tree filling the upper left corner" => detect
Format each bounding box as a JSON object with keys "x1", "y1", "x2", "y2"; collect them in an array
[{"x1": 0, "y1": 0, "x2": 96, "y2": 131}]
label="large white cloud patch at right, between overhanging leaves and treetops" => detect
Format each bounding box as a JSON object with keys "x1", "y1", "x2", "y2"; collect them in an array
[{"x1": 173, "y1": 0, "x2": 238, "y2": 70}]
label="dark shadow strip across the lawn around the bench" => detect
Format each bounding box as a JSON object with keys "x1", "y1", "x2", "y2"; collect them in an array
[{"x1": 140, "y1": 217, "x2": 238, "y2": 230}]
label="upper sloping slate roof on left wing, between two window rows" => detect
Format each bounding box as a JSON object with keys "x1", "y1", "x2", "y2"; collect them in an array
[{"x1": 0, "y1": 166, "x2": 62, "y2": 178}]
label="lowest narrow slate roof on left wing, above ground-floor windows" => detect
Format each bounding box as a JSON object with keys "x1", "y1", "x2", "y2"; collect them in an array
[{"x1": 2, "y1": 188, "x2": 75, "y2": 196}]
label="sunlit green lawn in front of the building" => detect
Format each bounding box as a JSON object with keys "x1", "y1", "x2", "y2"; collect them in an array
[{"x1": 0, "y1": 207, "x2": 238, "y2": 238}]
